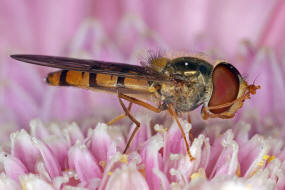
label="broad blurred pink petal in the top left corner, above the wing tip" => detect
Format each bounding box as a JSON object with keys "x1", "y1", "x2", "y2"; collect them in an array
[{"x1": 0, "y1": 0, "x2": 86, "y2": 54}]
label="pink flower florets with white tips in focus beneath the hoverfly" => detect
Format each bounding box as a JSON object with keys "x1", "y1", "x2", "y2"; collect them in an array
[{"x1": 0, "y1": 120, "x2": 285, "y2": 190}]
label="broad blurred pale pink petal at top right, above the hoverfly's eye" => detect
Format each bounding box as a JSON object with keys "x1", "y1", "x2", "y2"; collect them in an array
[{"x1": 203, "y1": 0, "x2": 275, "y2": 55}]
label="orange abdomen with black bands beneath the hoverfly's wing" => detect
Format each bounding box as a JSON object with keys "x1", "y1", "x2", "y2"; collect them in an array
[{"x1": 47, "y1": 70, "x2": 149, "y2": 92}]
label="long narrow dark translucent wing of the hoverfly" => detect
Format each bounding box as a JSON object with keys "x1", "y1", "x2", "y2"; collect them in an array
[{"x1": 11, "y1": 55, "x2": 171, "y2": 82}]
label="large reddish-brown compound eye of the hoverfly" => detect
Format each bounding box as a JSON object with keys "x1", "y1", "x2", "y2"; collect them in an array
[{"x1": 208, "y1": 62, "x2": 240, "y2": 114}]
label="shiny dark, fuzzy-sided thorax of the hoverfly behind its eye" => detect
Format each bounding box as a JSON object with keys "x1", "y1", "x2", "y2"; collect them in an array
[{"x1": 155, "y1": 57, "x2": 213, "y2": 112}]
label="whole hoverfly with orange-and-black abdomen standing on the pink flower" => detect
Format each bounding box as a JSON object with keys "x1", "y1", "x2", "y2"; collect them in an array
[{"x1": 11, "y1": 55, "x2": 260, "y2": 160}]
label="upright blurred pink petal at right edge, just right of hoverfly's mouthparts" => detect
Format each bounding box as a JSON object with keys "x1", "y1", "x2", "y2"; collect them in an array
[{"x1": 243, "y1": 49, "x2": 285, "y2": 131}]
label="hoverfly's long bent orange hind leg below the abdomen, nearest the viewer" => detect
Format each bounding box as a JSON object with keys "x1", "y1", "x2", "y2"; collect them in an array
[{"x1": 118, "y1": 92, "x2": 161, "y2": 154}]
